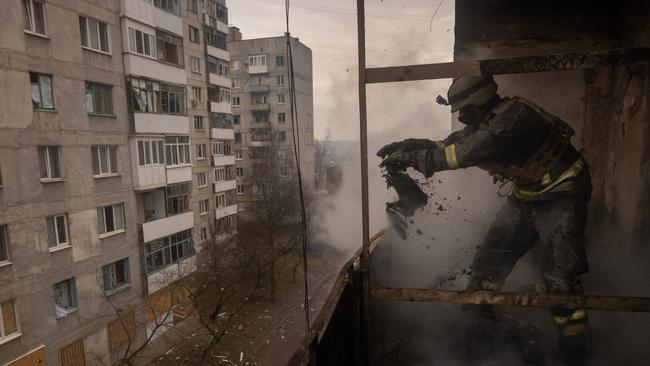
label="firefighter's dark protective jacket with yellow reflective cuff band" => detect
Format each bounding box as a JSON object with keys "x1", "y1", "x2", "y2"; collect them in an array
[{"x1": 417, "y1": 97, "x2": 587, "y2": 199}]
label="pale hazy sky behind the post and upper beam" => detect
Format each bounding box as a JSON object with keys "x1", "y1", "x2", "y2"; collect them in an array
[{"x1": 227, "y1": 0, "x2": 454, "y2": 144}]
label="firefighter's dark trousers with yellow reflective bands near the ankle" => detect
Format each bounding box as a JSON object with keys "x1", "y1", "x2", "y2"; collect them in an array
[{"x1": 468, "y1": 187, "x2": 591, "y2": 352}]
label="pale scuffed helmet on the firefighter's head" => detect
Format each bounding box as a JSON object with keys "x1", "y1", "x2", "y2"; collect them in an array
[{"x1": 447, "y1": 75, "x2": 498, "y2": 113}]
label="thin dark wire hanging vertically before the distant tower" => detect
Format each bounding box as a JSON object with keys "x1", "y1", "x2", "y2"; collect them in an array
[{"x1": 285, "y1": 0, "x2": 309, "y2": 333}]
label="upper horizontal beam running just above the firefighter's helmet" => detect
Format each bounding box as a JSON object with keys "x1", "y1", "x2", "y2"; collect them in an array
[{"x1": 366, "y1": 47, "x2": 650, "y2": 84}]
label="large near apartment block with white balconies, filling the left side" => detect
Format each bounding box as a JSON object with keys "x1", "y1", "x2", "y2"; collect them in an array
[{"x1": 0, "y1": 0, "x2": 237, "y2": 365}]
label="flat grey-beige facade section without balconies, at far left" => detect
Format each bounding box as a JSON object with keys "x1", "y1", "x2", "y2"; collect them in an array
[{"x1": 0, "y1": 0, "x2": 143, "y2": 365}]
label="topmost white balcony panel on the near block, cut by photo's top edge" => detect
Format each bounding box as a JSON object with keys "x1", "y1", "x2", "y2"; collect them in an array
[{"x1": 121, "y1": 0, "x2": 180, "y2": 36}]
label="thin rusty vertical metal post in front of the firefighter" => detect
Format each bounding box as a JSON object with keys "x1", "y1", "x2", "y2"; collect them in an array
[{"x1": 357, "y1": 0, "x2": 370, "y2": 364}]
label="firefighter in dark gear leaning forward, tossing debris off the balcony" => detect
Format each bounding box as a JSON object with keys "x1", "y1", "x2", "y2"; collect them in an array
[{"x1": 377, "y1": 76, "x2": 591, "y2": 364}]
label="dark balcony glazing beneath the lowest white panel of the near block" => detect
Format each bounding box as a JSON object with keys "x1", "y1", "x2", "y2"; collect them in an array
[{"x1": 144, "y1": 229, "x2": 194, "y2": 274}]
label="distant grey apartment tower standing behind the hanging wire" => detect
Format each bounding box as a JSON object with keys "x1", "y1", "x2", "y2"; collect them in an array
[{"x1": 228, "y1": 27, "x2": 314, "y2": 209}]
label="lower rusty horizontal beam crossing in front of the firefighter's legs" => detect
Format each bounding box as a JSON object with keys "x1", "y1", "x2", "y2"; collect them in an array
[{"x1": 371, "y1": 288, "x2": 650, "y2": 312}]
